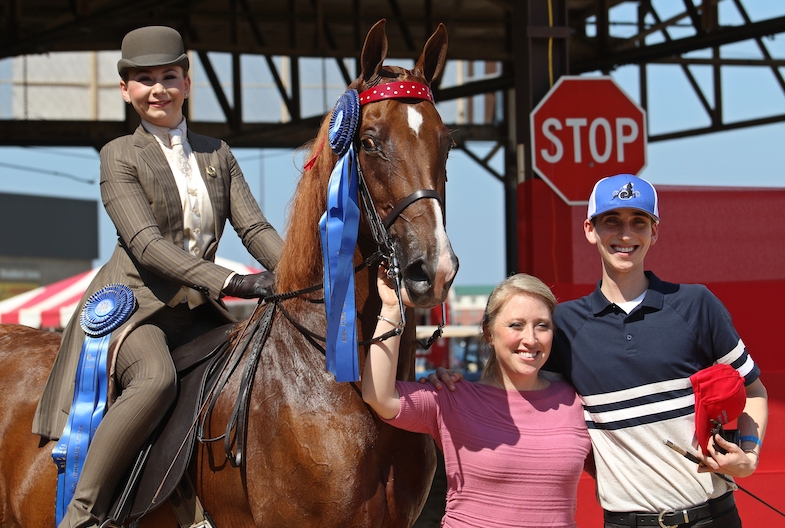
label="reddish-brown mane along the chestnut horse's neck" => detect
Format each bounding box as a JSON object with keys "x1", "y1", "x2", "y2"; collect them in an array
[{"x1": 275, "y1": 114, "x2": 337, "y2": 292}]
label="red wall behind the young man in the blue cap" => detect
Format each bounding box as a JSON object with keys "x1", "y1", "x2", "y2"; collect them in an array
[{"x1": 519, "y1": 184, "x2": 785, "y2": 528}]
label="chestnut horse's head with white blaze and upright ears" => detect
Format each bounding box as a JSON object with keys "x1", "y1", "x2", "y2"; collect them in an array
[{"x1": 351, "y1": 20, "x2": 458, "y2": 308}]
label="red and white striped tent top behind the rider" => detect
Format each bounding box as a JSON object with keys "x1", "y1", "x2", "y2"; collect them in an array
[{"x1": 0, "y1": 257, "x2": 261, "y2": 328}]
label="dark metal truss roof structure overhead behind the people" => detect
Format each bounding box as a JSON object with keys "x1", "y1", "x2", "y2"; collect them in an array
[{"x1": 0, "y1": 0, "x2": 785, "y2": 270}]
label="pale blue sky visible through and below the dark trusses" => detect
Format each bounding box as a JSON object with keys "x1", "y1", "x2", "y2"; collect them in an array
[{"x1": 0, "y1": 0, "x2": 785, "y2": 286}]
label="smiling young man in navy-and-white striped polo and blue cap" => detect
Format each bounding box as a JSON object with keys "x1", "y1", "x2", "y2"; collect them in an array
[{"x1": 429, "y1": 175, "x2": 768, "y2": 528}]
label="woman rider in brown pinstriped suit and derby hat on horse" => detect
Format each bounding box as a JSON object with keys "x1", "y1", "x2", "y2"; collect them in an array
[{"x1": 33, "y1": 26, "x2": 282, "y2": 528}]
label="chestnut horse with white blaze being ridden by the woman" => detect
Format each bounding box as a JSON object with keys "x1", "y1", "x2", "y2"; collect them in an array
[{"x1": 0, "y1": 20, "x2": 458, "y2": 528}]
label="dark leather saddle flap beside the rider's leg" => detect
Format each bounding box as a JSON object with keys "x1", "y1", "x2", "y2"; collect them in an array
[{"x1": 110, "y1": 323, "x2": 235, "y2": 524}]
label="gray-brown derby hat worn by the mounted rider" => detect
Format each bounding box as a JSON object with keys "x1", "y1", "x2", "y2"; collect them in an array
[{"x1": 117, "y1": 26, "x2": 188, "y2": 77}]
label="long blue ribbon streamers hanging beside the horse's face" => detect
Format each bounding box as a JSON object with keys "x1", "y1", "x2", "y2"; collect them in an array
[{"x1": 319, "y1": 148, "x2": 360, "y2": 381}]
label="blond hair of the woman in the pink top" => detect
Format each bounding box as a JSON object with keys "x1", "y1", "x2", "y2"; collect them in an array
[{"x1": 482, "y1": 273, "x2": 556, "y2": 378}]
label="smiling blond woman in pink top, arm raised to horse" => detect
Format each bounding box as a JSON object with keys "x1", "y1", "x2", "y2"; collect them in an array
[{"x1": 362, "y1": 268, "x2": 591, "y2": 528}]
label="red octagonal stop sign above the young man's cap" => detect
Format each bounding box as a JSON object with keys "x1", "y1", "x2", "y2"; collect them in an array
[{"x1": 529, "y1": 76, "x2": 646, "y2": 205}]
